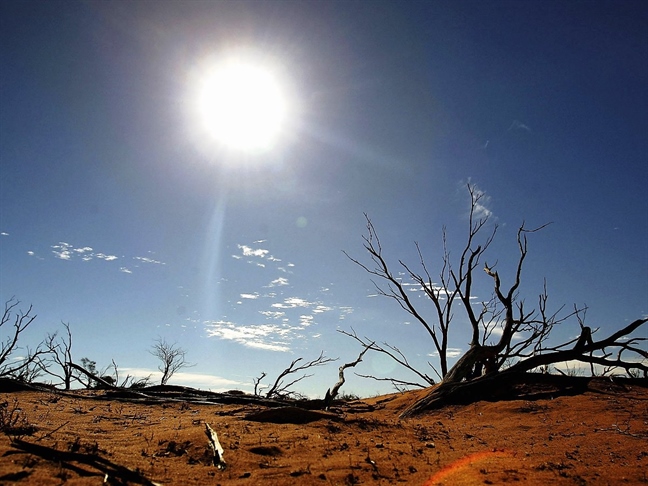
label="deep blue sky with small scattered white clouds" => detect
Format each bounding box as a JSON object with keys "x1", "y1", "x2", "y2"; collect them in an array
[{"x1": 0, "y1": 0, "x2": 648, "y2": 395}]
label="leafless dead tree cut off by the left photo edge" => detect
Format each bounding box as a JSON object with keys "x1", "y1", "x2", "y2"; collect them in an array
[{"x1": 0, "y1": 297, "x2": 45, "y2": 381}]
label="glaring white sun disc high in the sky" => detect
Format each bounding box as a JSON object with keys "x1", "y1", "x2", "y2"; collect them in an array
[{"x1": 198, "y1": 60, "x2": 287, "y2": 152}]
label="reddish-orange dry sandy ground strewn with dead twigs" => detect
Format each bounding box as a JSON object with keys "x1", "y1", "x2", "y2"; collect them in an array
[{"x1": 0, "y1": 380, "x2": 648, "y2": 485}]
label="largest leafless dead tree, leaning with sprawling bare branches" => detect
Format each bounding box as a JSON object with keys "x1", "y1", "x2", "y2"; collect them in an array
[{"x1": 342, "y1": 184, "x2": 648, "y2": 415}]
